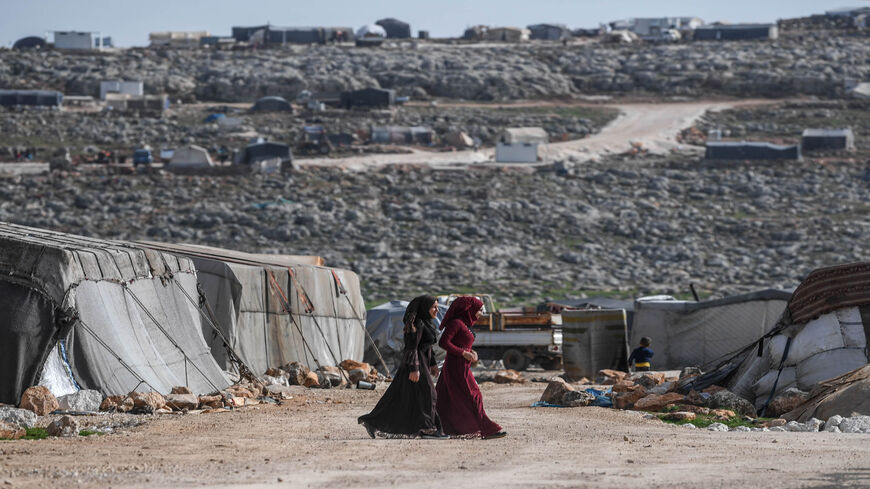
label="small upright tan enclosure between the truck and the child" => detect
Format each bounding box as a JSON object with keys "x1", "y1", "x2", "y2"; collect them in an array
[{"x1": 562, "y1": 309, "x2": 628, "y2": 380}]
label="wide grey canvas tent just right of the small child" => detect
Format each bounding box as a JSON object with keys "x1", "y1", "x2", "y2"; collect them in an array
[{"x1": 629, "y1": 289, "x2": 790, "y2": 370}]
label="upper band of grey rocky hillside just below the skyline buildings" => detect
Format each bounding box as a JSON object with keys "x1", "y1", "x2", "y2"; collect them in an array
[{"x1": 0, "y1": 24, "x2": 870, "y2": 102}]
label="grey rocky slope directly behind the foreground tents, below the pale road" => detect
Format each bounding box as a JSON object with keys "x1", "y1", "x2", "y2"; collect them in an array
[{"x1": 0, "y1": 159, "x2": 870, "y2": 303}]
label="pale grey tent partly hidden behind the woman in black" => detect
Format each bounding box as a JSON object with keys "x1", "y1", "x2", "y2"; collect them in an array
[{"x1": 363, "y1": 301, "x2": 447, "y2": 373}]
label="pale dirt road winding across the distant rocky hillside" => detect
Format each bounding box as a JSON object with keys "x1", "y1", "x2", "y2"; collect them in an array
[{"x1": 296, "y1": 100, "x2": 775, "y2": 170}]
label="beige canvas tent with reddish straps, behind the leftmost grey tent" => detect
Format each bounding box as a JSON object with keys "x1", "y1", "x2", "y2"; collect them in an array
[{"x1": 142, "y1": 242, "x2": 365, "y2": 374}]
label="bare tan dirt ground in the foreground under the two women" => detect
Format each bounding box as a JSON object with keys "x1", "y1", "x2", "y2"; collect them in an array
[{"x1": 0, "y1": 383, "x2": 870, "y2": 489}]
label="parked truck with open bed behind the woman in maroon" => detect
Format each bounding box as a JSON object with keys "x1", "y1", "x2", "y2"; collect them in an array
[{"x1": 439, "y1": 294, "x2": 562, "y2": 370}]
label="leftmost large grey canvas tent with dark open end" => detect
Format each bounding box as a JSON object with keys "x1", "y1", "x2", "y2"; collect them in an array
[{"x1": 0, "y1": 223, "x2": 229, "y2": 404}]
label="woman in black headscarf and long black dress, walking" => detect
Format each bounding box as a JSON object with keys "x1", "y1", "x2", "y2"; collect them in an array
[{"x1": 358, "y1": 295, "x2": 447, "y2": 438}]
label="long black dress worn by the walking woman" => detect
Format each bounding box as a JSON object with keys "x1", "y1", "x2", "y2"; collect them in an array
[{"x1": 358, "y1": 319, "x2": 442, "y2": 435}]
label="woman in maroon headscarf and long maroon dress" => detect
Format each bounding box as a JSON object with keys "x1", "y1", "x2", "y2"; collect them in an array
[{"x1": 435, "y1": 297, "x2": 507, "y2": 439}]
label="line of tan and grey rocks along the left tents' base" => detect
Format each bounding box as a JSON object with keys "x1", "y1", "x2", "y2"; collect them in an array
[{"x1": 0, "y1": 360, "x2": 386, "y2": 439}]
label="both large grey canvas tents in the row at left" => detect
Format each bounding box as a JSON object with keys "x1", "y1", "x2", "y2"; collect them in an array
[{"x1": 0, "y1": 223, "x2": 365, "y2": 404}]
